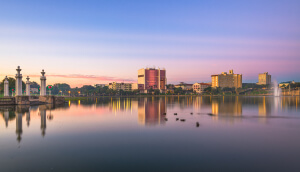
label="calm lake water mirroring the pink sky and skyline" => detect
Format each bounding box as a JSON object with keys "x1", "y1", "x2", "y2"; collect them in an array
[{"x1": 0, "y1": 96, "x2": 300, "y2": 172}]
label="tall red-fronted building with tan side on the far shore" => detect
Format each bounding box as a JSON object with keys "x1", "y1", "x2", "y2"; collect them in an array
[{"x1": 138, "y1": 68, "x2": 167, "y2": 93}]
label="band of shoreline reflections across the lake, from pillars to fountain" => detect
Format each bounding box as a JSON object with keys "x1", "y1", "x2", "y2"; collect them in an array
[{"x1": 0, "y1": 96, "x2": 299, "y2": 142}]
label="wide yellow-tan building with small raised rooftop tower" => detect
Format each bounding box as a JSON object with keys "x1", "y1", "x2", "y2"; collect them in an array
[{"x1": 211, "y1": 70, "x2": 242, "y2": 88}]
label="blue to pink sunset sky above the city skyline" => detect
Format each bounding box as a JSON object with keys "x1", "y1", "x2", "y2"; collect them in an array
[{"x1": 0, "y1": 0, "x2": 300, "y2": 87}]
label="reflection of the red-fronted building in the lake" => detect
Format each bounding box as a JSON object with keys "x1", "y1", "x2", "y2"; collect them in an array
[{"x1": 138, "y1": 97, "x2": 166, "y2": 126}]
